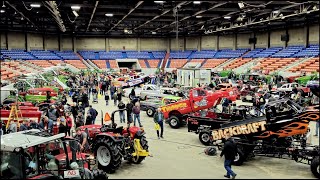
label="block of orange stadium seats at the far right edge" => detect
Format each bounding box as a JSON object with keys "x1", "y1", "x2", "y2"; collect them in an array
[{"x1": 289, "y1": 57, "x2": 319, "y2": 73}]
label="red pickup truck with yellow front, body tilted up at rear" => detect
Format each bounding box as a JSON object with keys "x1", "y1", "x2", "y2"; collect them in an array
[{"x1": 161, "y1": 88, "x2": 233, "y2": 129}]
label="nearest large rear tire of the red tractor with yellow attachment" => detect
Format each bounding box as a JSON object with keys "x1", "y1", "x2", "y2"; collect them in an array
[{"x1": 93, "y1": 138, "x2": 122, "y2": 173}]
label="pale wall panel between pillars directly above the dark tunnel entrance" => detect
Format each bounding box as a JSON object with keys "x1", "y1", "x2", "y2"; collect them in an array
[{"x1": 109, "y1": 38, "x2": 138, "y2": 51}]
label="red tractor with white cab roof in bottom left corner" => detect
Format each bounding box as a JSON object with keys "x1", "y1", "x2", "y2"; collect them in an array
[{"x1": 1, "y1": 129, "x2": 108, "y2": 179}]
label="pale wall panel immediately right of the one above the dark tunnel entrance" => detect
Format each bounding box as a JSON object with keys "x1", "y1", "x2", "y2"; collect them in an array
[{"x1": 140, "y1": 38, "x2": 168, "y2": 51}]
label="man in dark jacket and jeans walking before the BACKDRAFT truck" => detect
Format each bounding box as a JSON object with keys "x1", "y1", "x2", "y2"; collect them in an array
[{"x1": 220, "y1": 134, "x2": 237, "y2": 179}]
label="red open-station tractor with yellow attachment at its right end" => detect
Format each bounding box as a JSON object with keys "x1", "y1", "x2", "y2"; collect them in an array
[{"x1": 80, "y1": 109, "x2": 149, "y2": 173}]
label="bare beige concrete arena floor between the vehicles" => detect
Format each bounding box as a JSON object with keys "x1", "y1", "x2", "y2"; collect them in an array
[{"x1": 84, "y1": 97, "x2": 319, "y2": 179}]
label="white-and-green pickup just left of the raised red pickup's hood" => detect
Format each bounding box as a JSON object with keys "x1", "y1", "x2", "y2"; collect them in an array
[{"x1": 140, "y1": 95, "x2": 181, "y2": 117}]
